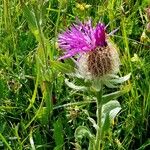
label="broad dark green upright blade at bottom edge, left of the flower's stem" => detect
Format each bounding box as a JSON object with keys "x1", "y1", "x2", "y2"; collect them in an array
[{"x1": 54, "y1": 119, "x2": 64, "y2": 150}]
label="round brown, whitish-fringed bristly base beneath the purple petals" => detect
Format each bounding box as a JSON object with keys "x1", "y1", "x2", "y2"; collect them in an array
[{"x1": 78, "y1": 43, "x2": 120, "y2": 79}]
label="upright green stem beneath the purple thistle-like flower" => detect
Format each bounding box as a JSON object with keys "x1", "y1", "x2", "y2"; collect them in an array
[{"x1": 95, "y1": 87, "x2": 102, "y2": 150}]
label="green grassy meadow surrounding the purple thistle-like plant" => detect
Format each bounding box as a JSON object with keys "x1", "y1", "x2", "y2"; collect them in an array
[{"x1": 0, "y1": 0, "x2": 150, "y2": 150}]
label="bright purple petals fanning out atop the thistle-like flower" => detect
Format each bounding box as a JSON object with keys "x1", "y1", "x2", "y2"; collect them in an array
[{"x1": 58, "y1": 20, "x2": 107, "y2": 59}]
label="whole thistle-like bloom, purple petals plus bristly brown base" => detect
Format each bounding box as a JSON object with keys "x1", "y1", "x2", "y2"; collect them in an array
[{"x1": 58, "y1": 20, "x2": 120, "y2": 85}]
